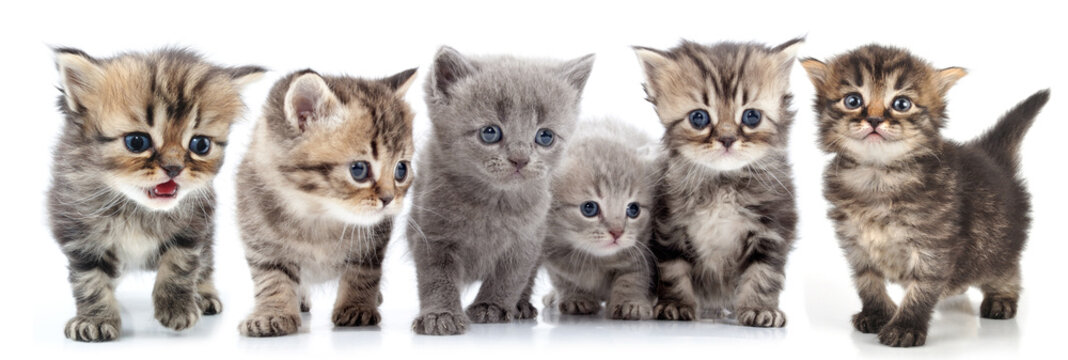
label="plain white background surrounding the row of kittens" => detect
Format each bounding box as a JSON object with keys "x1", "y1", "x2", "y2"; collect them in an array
[{"x1": 0, "y1": 0, "x2": 1068, "y2": 359}]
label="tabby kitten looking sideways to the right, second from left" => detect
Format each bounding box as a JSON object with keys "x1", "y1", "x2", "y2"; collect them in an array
[{"x1": 237, "y1": 68, "x2": 415, "y2": 336}]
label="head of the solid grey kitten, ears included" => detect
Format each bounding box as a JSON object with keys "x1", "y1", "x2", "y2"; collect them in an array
[{"x1": 426, "y1": 47, "x2": 593, "y2": 189}]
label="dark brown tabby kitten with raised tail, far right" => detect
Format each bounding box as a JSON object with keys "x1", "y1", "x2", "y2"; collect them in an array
[{"x1": 802, "y1": 45, "x2": 1049, "y2": 346}]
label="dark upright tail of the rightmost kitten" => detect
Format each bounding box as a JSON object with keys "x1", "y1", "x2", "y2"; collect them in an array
[{"x1": 972, "y1": 89, "x2": 1050, "y2": 172}]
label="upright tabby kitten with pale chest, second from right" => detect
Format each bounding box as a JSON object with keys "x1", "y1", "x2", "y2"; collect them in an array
[{"x1": 635, "y1": 38, "x2": 802, "y2": 327}]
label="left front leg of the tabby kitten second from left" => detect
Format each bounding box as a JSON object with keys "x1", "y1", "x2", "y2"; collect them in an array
[{"x1": 237, "y1": 259, "x2": 301, "y2": 338}]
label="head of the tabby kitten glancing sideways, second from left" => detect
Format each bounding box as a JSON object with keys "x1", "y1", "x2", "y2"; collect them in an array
[{"x1": 262, "y1": 68, "x2": 415, "y2": 225}]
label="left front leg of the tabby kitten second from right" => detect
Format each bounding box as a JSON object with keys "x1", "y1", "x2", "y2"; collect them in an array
[{"x1": 653, "y1": 259, "x2": 697, "y2": 322}]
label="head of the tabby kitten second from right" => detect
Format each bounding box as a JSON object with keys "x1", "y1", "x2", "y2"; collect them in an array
[{"x1": 635, "y1": 40, "x2": 801, "y2": 171}]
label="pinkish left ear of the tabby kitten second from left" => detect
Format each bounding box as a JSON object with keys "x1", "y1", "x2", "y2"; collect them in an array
[{"x1": 285, "y1": 72, "x2": 340, "y2": 134}]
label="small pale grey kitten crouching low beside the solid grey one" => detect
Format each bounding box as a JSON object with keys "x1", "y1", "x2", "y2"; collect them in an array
[{"x1": 543, "y1": 121, "x2": 659, "y2": 319}]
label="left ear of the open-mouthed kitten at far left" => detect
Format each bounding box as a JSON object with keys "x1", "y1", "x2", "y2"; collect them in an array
[{"x1": 56, "y1": 48, "x2": 104, "y2": 112}]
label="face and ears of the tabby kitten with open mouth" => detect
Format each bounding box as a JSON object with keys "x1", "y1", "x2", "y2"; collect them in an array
[{"x1": 57, "y1": 49, "x2": 264, "y2": 210}]
